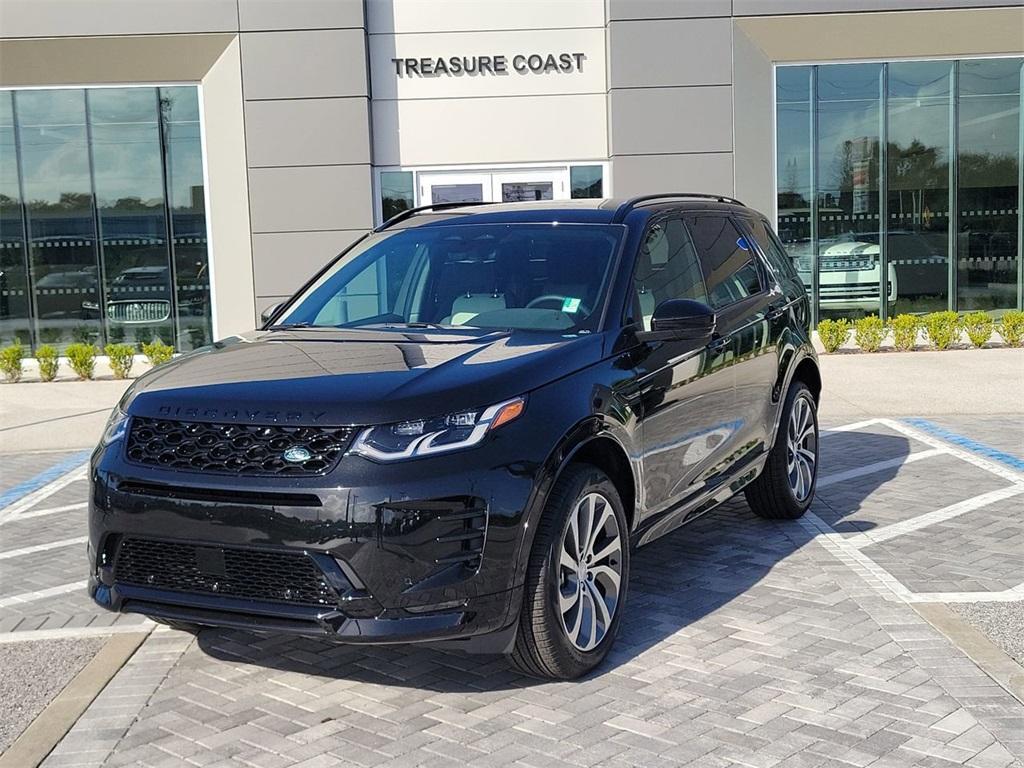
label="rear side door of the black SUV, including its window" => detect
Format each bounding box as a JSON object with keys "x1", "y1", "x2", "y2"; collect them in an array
[{"x1": 687, "y1": 211, "x2": 784, "y2": 474}]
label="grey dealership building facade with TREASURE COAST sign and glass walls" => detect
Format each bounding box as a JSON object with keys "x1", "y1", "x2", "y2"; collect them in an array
[{"x1": 0, "y1": 0, "x2": 1024, "y2": 350}]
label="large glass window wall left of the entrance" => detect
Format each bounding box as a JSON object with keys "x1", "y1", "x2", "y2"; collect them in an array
[{"x1": 0, "y1": 87, "x2": 212, "y2": 350}]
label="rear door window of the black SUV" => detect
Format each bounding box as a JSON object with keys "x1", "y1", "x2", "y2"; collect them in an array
[{"x1": 686, "y1": 213, "x2": 762, "y2": 309}]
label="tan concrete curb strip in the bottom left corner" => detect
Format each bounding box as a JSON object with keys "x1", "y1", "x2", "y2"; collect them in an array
[{"x1": 0, "y1": 632, "x2": 150, "y2": 768}]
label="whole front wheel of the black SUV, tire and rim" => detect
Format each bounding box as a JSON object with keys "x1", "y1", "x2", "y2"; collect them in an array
[{"x1": 512, "y1": 464, "x2": 630, "y2": 680}]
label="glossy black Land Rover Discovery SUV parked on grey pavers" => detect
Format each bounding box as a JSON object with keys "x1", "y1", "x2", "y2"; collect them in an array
[{"x1": 89, "y1": 195, "x2": 821, "y2": 678}]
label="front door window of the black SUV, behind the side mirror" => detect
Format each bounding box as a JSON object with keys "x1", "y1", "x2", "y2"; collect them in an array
[{"x1": 633, "y1": 218, "x2": 708, "y2": 331}]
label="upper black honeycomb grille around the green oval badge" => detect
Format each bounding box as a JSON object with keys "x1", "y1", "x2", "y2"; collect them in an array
[{"x1": 127, "y1": 416, "x2": 355, "y2": 475}]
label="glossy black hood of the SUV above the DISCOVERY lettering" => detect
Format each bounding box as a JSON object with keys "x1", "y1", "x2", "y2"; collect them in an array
[{"x1": 122, "y1": 328, "x2": 602, "y2": 426}]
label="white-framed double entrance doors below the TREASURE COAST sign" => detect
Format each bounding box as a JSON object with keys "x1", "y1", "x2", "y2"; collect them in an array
[{"x1": 419, "y1": 168, "x2": 569, "y2": 205}]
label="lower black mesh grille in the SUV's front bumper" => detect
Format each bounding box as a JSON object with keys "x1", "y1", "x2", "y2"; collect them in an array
[{"x1": 114, "y1": 538, "x2": 339, "y2": 605}]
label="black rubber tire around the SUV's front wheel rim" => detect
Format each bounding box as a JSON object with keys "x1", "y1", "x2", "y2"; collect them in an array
[{"x1": 511, "y1": 464, "x2": 630, "y2": 680}]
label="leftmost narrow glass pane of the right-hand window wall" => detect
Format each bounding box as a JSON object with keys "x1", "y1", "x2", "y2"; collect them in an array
[{"x1": 775, "y1": 67, "x2": 814, "y2": 305}]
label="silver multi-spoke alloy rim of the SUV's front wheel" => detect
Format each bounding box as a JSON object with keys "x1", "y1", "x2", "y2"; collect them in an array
[{"x1": 558, "y1": 493, "x2": 623, "y2": 651}]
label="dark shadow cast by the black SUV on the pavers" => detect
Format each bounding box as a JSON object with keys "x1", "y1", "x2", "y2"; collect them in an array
[{"x1": 193, "y1": 432, "x2": 910, "y2": 692}]
